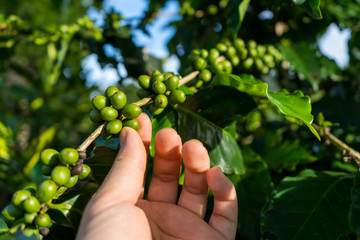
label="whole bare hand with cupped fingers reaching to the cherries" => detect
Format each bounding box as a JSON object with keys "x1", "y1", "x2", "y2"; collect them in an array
[{"x1": 77, "y1": 114, "x2": 238, "y2": 240}]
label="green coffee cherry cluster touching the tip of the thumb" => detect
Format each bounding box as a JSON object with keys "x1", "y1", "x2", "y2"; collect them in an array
[{"x1": 90, "y1": 86, "x2": 142, "y2": 140}]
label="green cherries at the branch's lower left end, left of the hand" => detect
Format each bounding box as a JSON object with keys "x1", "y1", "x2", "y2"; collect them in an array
[{"x1": 2, "y1": 148, "x2": 91, "y2": 235}]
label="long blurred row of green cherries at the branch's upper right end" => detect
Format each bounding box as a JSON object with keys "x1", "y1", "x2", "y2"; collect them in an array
[{"x1": 189, "y1": 38, "x2": 282, "y2": 88}]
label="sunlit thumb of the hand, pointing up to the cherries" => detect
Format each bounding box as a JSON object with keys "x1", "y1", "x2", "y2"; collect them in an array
[{"x1": 96, "y1": 127, "x2": 146, "y2": 207}]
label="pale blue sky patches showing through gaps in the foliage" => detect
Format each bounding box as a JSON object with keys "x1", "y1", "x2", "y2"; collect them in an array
[{"x1": 82, "y1": 0, "x2": 351, "y2": 89}]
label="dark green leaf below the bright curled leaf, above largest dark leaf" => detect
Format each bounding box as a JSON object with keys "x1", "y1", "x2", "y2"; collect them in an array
[{"x1": 264, "y1": 139, "x2": 317, "y2": 172}]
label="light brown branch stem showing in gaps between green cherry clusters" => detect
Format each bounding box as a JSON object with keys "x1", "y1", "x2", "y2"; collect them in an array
[{"x1": 77, "y1": 71, "x2": 200, "y2": 152}]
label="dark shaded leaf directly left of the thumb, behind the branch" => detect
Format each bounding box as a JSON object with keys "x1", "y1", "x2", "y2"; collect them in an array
[{"x1": 86, "y1": 146, "x2": 118, "y2": 183}]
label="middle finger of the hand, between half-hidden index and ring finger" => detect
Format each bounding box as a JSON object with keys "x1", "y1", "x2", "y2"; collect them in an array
[{"x1": 147, "y1": 128, "x2": 182, "y2": 203}]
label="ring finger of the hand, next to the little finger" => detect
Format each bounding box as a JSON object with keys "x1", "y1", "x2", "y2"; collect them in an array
[{"x1": 178, "y1": 140, "x2": 210, "y2": 218}]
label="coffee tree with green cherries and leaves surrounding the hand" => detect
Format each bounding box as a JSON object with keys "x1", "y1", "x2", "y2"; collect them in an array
[{"x1": 0, "y1": 0, "x2": 360, "y2": 239}]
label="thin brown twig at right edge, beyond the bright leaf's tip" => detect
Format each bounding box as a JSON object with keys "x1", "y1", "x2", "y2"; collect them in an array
[{"x1": 312, "y1": 123, "x2": 360, "y2": 166}]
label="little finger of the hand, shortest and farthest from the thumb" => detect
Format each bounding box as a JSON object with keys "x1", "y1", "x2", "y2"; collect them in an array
[{"x1": 206, "y1": 167, "x2": 238, "y2": 239}]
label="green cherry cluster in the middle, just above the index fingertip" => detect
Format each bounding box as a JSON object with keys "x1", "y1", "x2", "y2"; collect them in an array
[{"x1": 137, "y1": 70, "x2": 186, "y2": 115}]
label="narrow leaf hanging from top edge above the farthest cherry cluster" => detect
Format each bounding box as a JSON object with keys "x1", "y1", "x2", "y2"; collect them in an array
[{"x1": 228, "y1": 0, "x2": 250, "y2": 36}]
